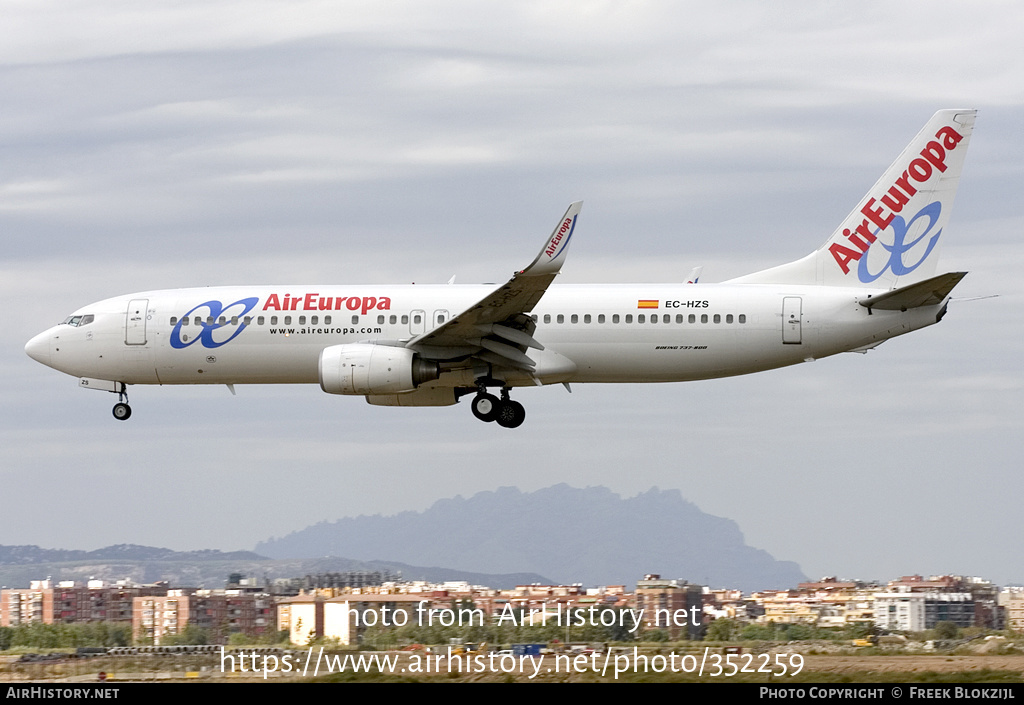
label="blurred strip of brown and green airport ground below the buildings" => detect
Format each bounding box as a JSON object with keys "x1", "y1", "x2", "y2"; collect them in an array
[{"x1": 0, "y1": 644, "x2": 1024, "y2": 685}]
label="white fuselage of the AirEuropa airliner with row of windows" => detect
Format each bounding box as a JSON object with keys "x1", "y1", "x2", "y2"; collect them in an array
[{"x1": 27, "y1": 284, "x2": 941, "y2": 386}]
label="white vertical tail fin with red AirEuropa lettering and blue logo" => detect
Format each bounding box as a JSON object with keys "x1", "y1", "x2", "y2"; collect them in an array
[{"x1": 732, "y1": 110, "x2": 977, "y2": 289}]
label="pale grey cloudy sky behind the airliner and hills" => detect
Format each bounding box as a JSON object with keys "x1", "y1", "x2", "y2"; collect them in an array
[{"x1": 0, "y1": 0, "x2": 1024, "y2": 583}]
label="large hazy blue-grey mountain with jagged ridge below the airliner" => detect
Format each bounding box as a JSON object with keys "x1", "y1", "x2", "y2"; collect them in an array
[{"x1": 256, "y1": 484, "x2": 807, "y2": 590}]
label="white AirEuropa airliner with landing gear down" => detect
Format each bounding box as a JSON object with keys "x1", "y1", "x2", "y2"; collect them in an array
[{"x1": 25, "y1": 110, "x2": 976, "y2": 427}]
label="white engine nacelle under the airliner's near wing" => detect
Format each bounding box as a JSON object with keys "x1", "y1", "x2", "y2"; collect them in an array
[{"x1": 319, "y1": 343, "x2": 440, "y2": 395}]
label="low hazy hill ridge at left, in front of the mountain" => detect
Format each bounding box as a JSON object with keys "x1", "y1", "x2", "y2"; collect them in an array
[{"x1": 0, "y1": 544, "x2": 551, "y2": 588}]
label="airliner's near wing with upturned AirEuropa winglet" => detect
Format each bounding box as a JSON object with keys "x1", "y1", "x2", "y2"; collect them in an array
[{"x1": 406, "y1": 201, "x2": 583, "y2": 370}]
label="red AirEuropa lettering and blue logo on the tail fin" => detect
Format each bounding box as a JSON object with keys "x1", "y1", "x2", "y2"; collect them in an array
[{"x1": 828, "y1": 126, "x2": 964, "y2": 281}]
